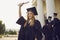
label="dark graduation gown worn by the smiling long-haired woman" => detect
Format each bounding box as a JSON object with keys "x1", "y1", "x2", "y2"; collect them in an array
[{"x1": 17, "y1": 17, "x2": 42, "y2": 40}]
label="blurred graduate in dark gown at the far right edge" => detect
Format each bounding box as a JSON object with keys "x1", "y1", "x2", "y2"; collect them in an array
[{"x1": 52, "y1": 13, "x2": 60, "y2": 40}]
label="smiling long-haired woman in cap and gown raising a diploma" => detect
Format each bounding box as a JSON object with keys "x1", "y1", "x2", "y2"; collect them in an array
[{"x1": 16, "y1": 3, "x2": 42, "y2": 40}]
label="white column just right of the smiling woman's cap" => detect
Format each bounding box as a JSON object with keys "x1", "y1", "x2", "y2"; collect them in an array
[{"x1": 37, "y1": 0, "x2": 44, "y2": 27}]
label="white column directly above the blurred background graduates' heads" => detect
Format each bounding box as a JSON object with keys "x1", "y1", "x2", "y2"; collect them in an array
[{"x1": 46, "y1": 0, "x2": 55, "y2": 18}]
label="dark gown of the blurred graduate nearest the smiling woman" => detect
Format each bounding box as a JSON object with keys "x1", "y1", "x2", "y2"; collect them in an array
[{"x1": 43, "y1": 22, "x2": 53, "y2": 40}]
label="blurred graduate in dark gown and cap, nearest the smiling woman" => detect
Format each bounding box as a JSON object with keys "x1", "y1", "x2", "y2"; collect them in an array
[{"x1": 43, "y1": 16, "x2": 53, "y2": 40}]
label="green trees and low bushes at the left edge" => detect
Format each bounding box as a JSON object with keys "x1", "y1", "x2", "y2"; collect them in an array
[{"x1": 0, "y1": 20, "x2": 17, "y2": 35}]
